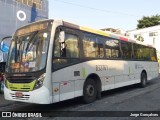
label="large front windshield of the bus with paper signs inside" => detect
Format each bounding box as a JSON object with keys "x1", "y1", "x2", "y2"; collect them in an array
[{"x1": 6, "y1": 20, "x2": 50, "y2": 73}]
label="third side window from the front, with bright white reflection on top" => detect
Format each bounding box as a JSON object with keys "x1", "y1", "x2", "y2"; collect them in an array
[{"x1": 105, "y1": 39, "x2": 120, "y2": 58}]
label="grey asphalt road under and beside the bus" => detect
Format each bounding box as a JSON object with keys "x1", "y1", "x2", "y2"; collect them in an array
[{"x1": 0, "y1": 74, "x2": 160, "y2": 120}]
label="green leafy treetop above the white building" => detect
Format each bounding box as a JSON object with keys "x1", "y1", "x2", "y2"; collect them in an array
[{"x1": 137, "y1": 14, "x2": 160, "y2": 29}]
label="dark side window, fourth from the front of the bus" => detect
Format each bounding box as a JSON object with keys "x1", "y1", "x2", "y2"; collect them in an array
[{"x1": 121, "y1": 41, "x2": 133, "y2": 59}]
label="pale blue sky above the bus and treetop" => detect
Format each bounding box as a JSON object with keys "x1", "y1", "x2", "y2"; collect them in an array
[{"x1": 49, "y1": 0, "x2": 160, "y2": 30}]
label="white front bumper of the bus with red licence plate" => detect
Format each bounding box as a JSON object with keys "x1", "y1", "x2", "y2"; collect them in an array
[{"x1": 4, "y1": 86, "x2": 52, "y2": 104}]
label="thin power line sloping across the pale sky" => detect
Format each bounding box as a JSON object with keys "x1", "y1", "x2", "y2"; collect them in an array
[{"x1": 54, "y1": 0, "x2": 141, "y2": 17}]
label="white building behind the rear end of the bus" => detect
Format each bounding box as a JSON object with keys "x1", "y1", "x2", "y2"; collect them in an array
[{"x1": 127, "y1": 25, "x2": 160, "y2": 62}]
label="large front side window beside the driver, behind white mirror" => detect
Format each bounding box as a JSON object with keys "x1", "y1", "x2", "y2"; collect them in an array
[{"x1": 53, "y1": 31, "x2": 79, "y2": 70}]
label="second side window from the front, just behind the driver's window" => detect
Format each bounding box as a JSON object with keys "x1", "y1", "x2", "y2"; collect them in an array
[{"x1": 83, "y1": 33, "x2": 104, "y2": 58}]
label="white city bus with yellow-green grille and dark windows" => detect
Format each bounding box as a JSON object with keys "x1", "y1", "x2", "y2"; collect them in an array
[{"x1": 4, "y1": 19, "x2": 158, "y2": 104}]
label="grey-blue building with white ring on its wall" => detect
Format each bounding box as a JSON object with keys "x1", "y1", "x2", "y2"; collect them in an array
[{"x1": 0, "y1": 0, "x2": 48, "y2": 39}]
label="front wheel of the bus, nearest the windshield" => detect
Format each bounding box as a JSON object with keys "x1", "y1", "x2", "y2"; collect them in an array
[{"x1": 83, "y1": 78, "x2": 97, "y2": 103}]
